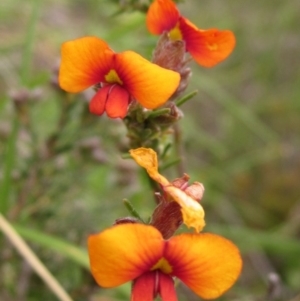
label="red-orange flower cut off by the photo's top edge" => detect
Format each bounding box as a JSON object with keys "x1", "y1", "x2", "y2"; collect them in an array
[{"x1": 146, "y1": 0, "x2": 235, "y2": 67}]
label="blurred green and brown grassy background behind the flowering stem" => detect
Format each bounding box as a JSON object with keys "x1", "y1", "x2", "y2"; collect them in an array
[{"x1": 0, "y1": 0, "x2": 300, "y2": 301}]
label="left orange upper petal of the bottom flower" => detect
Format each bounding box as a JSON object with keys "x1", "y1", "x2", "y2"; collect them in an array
[{"x1": 88, "y1": 224, "x2": 164, "y2": 287}]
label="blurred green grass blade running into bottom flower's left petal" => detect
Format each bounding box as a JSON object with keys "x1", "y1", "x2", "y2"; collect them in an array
[{"x1": 14, "y1": 224, "x2": 90, "y2": 270}]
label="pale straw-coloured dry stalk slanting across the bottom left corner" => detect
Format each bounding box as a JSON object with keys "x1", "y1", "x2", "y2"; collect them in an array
[{"x1": 0, "y1": 213, "x2": 72, "y2": 301}]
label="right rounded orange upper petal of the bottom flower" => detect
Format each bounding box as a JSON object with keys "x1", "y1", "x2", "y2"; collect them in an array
[{"x1": 164, "y1": 233, "x2": 242, "y2": 299}]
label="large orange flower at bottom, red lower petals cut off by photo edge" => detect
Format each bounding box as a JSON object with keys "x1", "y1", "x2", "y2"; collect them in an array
[{"x1": 88, "y1": 224, "x2": 242, "y2": 301}]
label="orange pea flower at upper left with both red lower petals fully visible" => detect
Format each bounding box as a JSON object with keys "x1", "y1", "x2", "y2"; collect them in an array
[{"x1": 59, "y1": 37, "x2": 180, "y2": 118}]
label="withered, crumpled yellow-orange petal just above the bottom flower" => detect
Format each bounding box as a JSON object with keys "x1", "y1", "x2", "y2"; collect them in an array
[{"x1": 129, "y1": 147, "x2": 205, "y2": 232}]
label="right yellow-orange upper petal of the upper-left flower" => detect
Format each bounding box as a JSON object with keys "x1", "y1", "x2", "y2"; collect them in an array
[{"x1": 115, "y1": 51, "x2": 180, "y2": 109}]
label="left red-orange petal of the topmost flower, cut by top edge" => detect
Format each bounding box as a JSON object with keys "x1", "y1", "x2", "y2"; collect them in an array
[{"x1": 146, "y1": 0, "x2": 180, "y2": 35}]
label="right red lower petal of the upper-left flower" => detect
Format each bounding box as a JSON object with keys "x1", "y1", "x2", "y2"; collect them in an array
[{"x1": 105, "y1": 85, "x2": 130, "y2": 118}]
